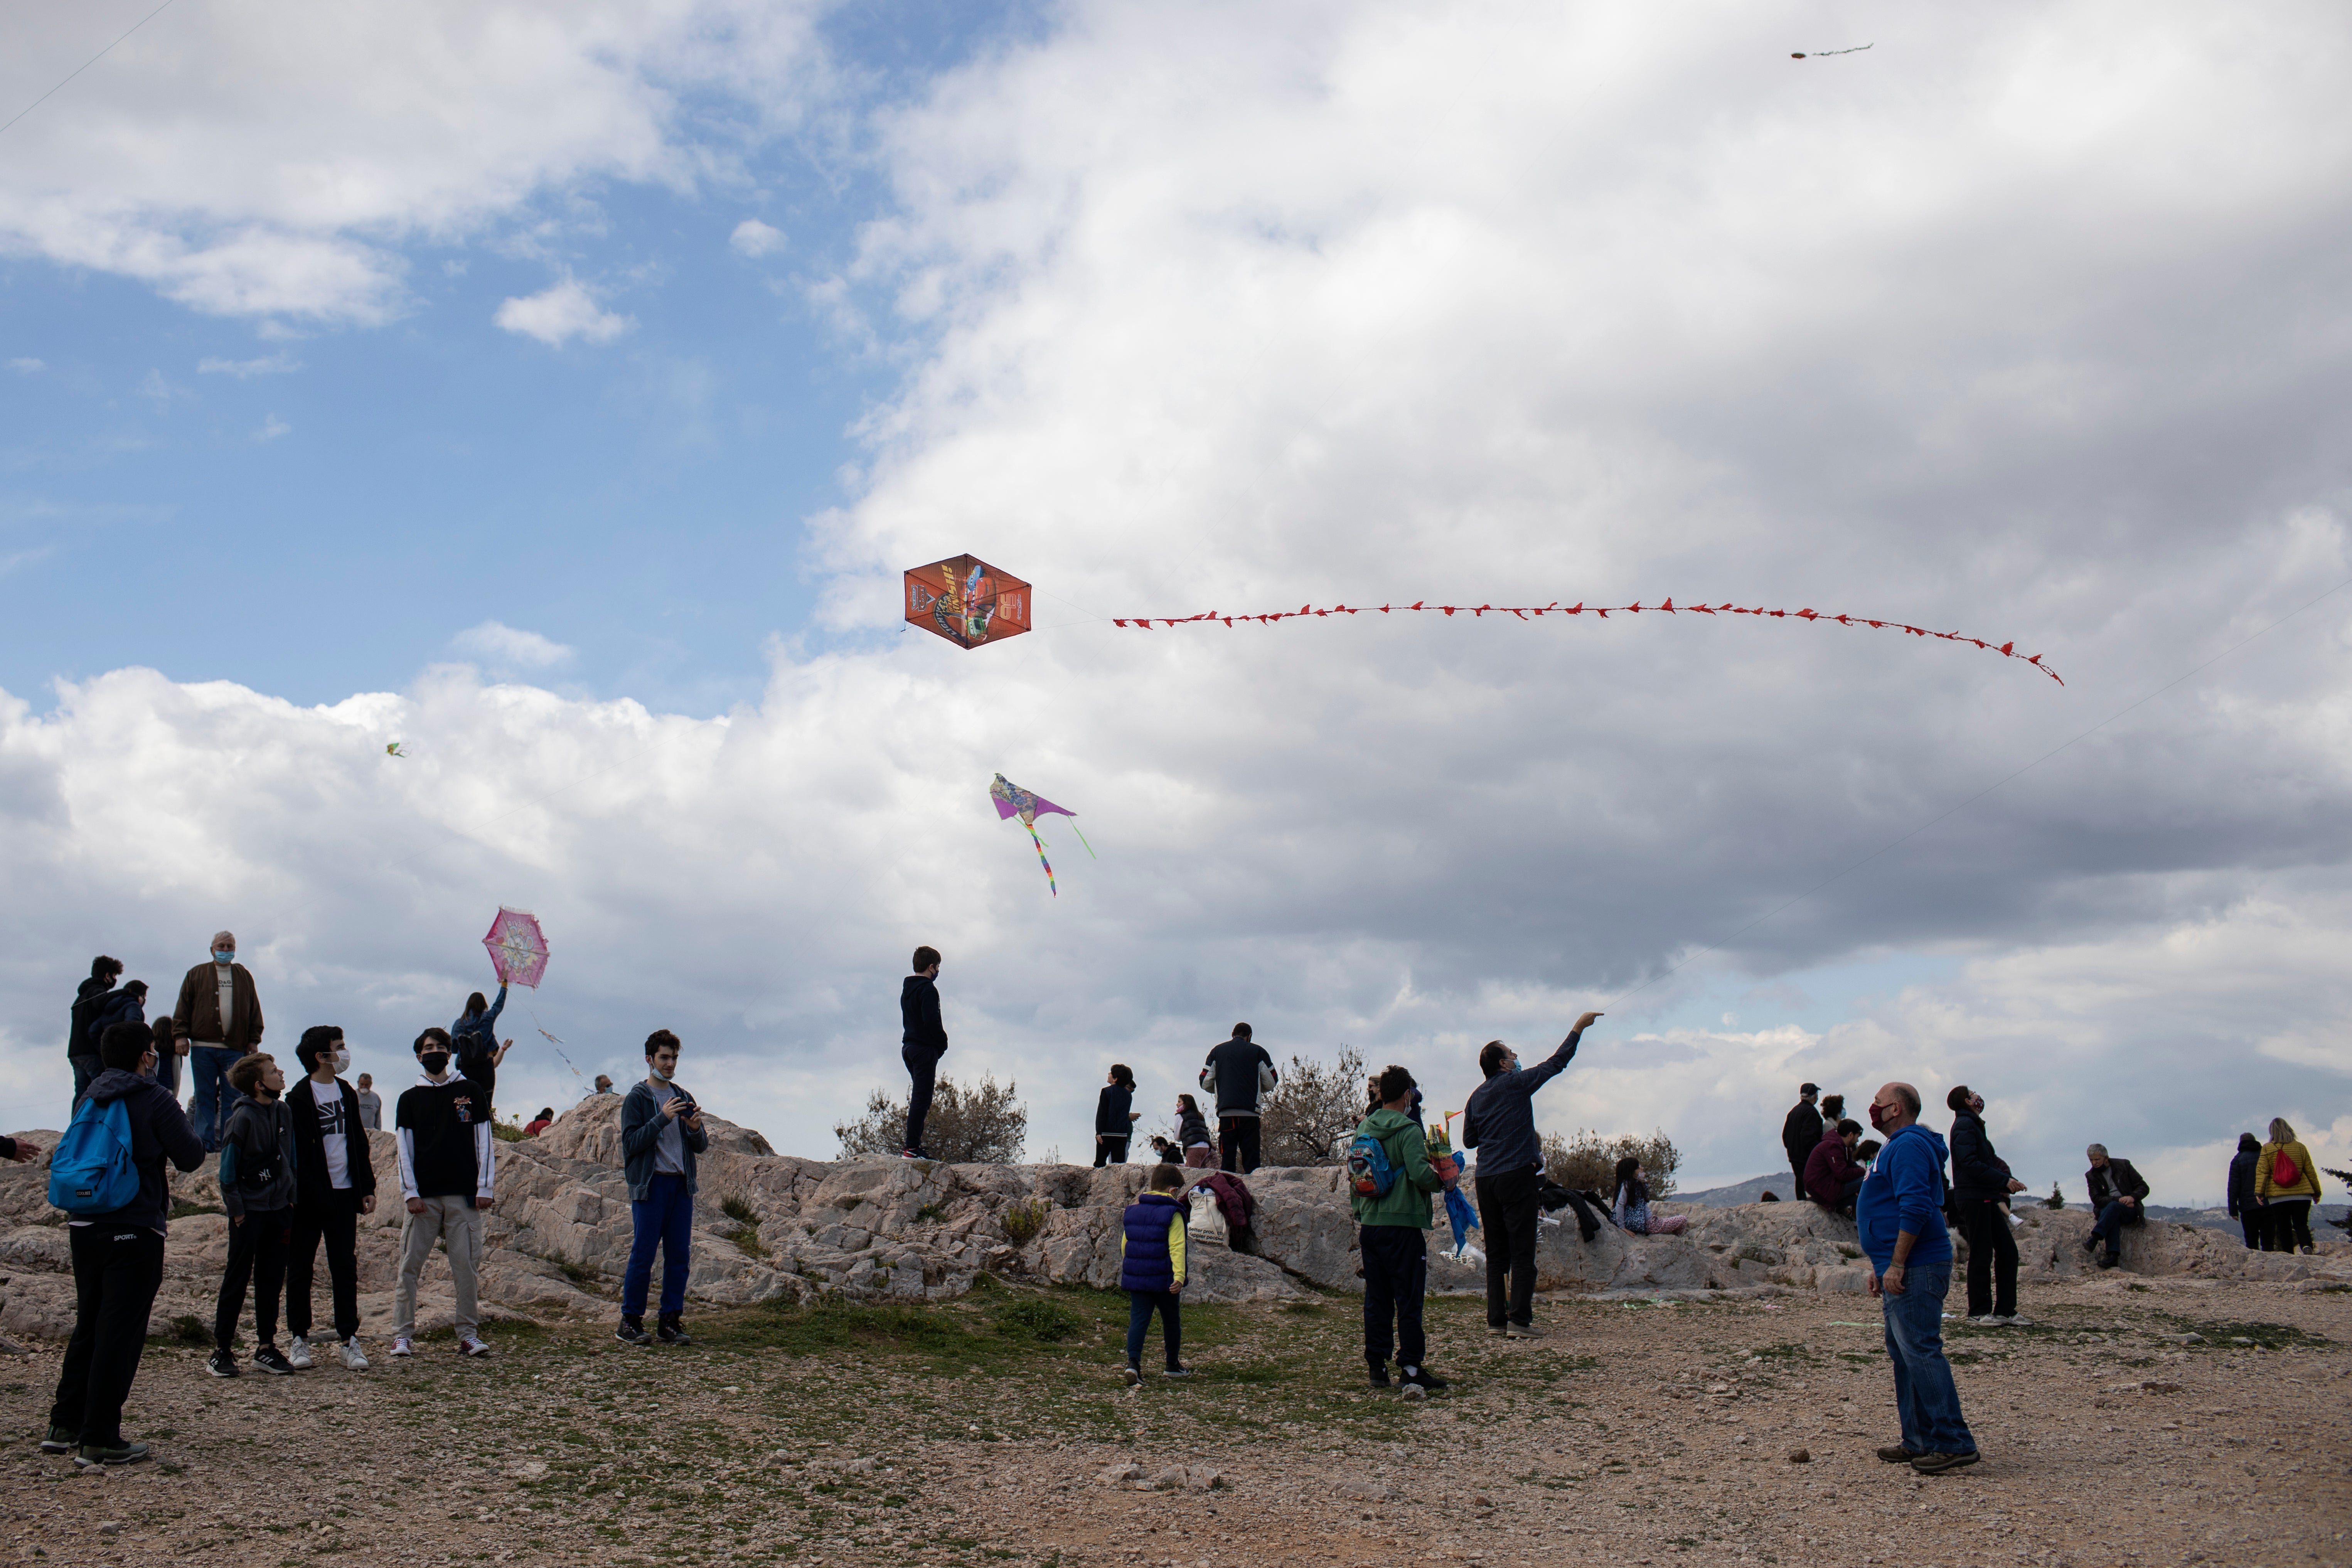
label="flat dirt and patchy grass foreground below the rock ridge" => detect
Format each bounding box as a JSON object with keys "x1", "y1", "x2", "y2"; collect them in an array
[{"x1": 0, "y1": 1279, "x2": 2352, "y2": 1568}]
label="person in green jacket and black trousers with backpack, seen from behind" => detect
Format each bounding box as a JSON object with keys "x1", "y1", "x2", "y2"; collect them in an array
[{"x1": 1345, "y1": 1067, "x2": 1447, "y2": 1396}]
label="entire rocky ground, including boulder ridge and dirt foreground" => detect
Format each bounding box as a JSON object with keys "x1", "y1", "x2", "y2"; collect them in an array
[{"x1": 0, "y1": 1100, "x2": 2352, "y2": 1568}]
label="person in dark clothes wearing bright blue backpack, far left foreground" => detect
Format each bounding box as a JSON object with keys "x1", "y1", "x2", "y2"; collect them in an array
[{"x1": 40, "y1": 1018, "x2": 205, "y2": 1469}]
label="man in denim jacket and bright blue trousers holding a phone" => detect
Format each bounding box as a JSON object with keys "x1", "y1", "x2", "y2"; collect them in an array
[{"x1": 612, "y1": 1030, "x2": 710, "y2": 1345}]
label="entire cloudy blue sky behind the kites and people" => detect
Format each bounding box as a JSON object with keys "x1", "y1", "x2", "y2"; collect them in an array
[{"x1": 0, "y1": 0, "x2": 2352, "y2": 1201}]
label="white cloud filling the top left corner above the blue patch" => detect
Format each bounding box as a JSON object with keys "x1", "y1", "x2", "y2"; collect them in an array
[{"x1": 0, "y1": 0, "x2": 816, "y2": 324}]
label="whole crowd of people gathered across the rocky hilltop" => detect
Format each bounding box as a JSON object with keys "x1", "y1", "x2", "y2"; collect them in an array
[{"x1": 18, "y1": 931, "x2": 2319, "y2": 1474}]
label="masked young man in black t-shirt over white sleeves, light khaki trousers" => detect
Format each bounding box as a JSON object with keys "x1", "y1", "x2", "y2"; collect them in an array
[{"x1": 393, "y1": 1030, "x2": 499, "y2": 1356}]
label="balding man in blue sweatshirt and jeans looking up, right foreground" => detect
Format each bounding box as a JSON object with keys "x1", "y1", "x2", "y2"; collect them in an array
[{"x1": 1853, "y1": 1084, "x2": 1976, "y2": 1476}]
